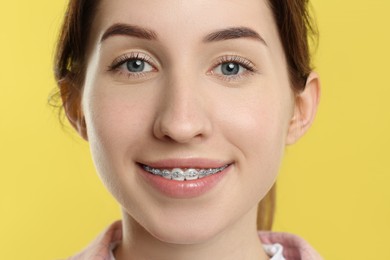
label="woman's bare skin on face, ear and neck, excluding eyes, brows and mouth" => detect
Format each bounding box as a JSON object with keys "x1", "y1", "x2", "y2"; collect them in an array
[{"x1": 64, "y1": 0, "x2": 319, "y2": 260}]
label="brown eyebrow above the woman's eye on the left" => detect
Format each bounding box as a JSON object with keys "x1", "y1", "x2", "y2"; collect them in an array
[{"x1": 100, "y1": 23, "x2": 157, "y2": 42}]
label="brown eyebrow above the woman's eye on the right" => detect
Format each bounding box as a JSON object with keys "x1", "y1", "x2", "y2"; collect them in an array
[{"x1": 203, "y1": 27, "x2": 268, "y2": 46}]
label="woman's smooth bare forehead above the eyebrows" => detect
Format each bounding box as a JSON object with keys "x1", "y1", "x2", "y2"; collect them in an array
[{"x1": 92, "y1": 0, "x2": 278, "y2": 47}]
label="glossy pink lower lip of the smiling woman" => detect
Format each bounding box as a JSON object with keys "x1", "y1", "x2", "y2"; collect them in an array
[{"x1": 139, "y1": 165, "x2": 231, "y2": 199}]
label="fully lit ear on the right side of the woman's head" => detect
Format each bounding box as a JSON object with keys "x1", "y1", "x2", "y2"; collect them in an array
[{"x1": 286, "y1": 72, "x2": 321, "y2": 145}]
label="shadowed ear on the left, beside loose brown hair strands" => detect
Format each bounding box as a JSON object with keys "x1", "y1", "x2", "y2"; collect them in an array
[{"x1": 59, "y1": 80, "x2": 88, "y2": 141}]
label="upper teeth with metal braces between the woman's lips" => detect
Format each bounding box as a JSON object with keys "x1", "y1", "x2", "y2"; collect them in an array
[{"x1": 141, "y1": 164, "x2": 229, "y2": 181}]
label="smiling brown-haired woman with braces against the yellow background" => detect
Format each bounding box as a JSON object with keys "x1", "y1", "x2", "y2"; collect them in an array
[{"x1": 55, "y1": 0, "x2": 320, "y2": 260}]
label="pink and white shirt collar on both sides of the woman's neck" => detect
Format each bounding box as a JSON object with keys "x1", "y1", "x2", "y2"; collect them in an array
[{"x1": 68, "y1": 221, "x2": 322, "y2": 260}]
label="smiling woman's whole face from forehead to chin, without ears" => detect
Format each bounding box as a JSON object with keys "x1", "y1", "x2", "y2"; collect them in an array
[{"x1": 82, "y1": 0, "x2": 294, "y2": 243}]
